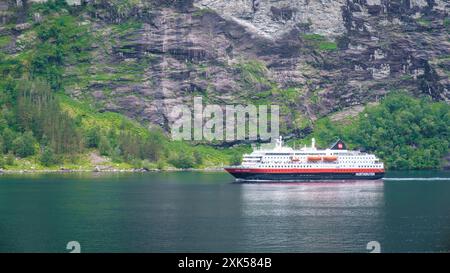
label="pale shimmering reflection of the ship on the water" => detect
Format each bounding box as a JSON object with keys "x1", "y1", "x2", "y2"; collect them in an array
[{"x1": 237, "y1": 180, "x2": 384, "y2": 252}]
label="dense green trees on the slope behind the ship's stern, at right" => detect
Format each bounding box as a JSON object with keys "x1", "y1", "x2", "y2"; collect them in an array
[{"x1": 290, "y1": 91, "x2": 450, "y2": 169}]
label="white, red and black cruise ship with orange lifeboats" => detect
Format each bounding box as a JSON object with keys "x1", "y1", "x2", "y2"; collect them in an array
[{"x1": 225, "y1": 137, "x2": 384, "y2": 182}]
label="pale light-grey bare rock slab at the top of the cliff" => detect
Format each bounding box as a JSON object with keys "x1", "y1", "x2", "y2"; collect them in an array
[{"x1": 194, "y1": 0, "x2": 347, "y2": 39}]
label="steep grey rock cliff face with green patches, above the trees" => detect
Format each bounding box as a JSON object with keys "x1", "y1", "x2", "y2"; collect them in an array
[{"x1": 0, "y1": 0, "x2": 450, "y2": 134}]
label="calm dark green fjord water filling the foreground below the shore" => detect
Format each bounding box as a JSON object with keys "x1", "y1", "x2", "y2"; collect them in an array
[{"x1": 0, "y1": 172, "x2": 450, "y2": 252}]
